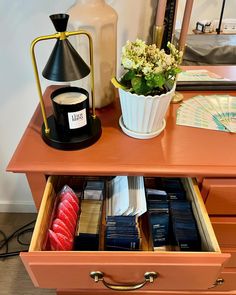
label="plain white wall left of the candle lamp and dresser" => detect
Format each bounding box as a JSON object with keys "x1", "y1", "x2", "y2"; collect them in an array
[{"x1": 0, "y1": 0, "x2": 73, "y2": 211}]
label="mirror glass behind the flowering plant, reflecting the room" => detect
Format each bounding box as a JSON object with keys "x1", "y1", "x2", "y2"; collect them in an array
[{"x1": 167, "y1": 0, "x2": 236, "y2": 90}]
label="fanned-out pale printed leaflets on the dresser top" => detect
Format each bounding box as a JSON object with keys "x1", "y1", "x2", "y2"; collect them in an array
[{"x1": 176, "y1": 95, "x2": 236, "y2": 133}]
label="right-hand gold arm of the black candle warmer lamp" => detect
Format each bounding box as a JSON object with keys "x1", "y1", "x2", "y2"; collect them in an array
[{"x1": 65, "y1": 30, "x2": 96, "y2": 118}]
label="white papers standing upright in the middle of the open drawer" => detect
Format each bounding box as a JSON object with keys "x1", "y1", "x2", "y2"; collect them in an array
[{"x1": 107, "y1": 176, "x2": 147, "y2": 216}]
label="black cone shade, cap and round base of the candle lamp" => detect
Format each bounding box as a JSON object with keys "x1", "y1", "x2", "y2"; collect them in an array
[{"x1": 42, "y1": 14, "x2": 102, "y2": 150}]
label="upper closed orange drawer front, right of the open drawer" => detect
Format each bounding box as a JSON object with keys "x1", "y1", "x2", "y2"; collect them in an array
[{"x1": 201, "y1": 178, "x2": 236, "y2": 215}]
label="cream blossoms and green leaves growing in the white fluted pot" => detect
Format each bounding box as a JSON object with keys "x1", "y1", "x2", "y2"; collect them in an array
[{"x1": 121, "y1": 39, "x2": 182, "y2": 94}]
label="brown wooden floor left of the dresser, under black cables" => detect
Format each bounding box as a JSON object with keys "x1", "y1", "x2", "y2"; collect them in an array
[{"x1": 0, "y1": 213, "x2": 56, "y2": 295}]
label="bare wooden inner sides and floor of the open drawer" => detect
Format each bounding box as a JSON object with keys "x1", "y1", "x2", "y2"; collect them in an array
[{"x1": 29, "y1": 176, "x2": 220, "y2": 252}]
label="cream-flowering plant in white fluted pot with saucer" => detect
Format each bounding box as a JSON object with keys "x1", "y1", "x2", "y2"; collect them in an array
[{"x1": 113, "y1": 39, "x2": 182, "y2": 139}]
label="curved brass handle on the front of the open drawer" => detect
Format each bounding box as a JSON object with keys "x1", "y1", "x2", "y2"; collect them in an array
[{"x1": 90, "y1": 271, "x2": 158, "y2": 291}]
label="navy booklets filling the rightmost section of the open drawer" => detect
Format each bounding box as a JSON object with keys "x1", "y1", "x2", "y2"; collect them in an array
[{"x1": 145, "y1": 177, "x2": 201, "y2": 251}]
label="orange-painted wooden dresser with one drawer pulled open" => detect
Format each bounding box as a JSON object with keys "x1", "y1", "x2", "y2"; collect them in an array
[{"x1": 7, "y1": 67, "x2": 236, "y2": 295}]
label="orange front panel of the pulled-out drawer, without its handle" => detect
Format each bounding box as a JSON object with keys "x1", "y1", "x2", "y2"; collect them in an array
[{"x1": 21, "y1": 252, "x2": 227, "y2": 290}]
